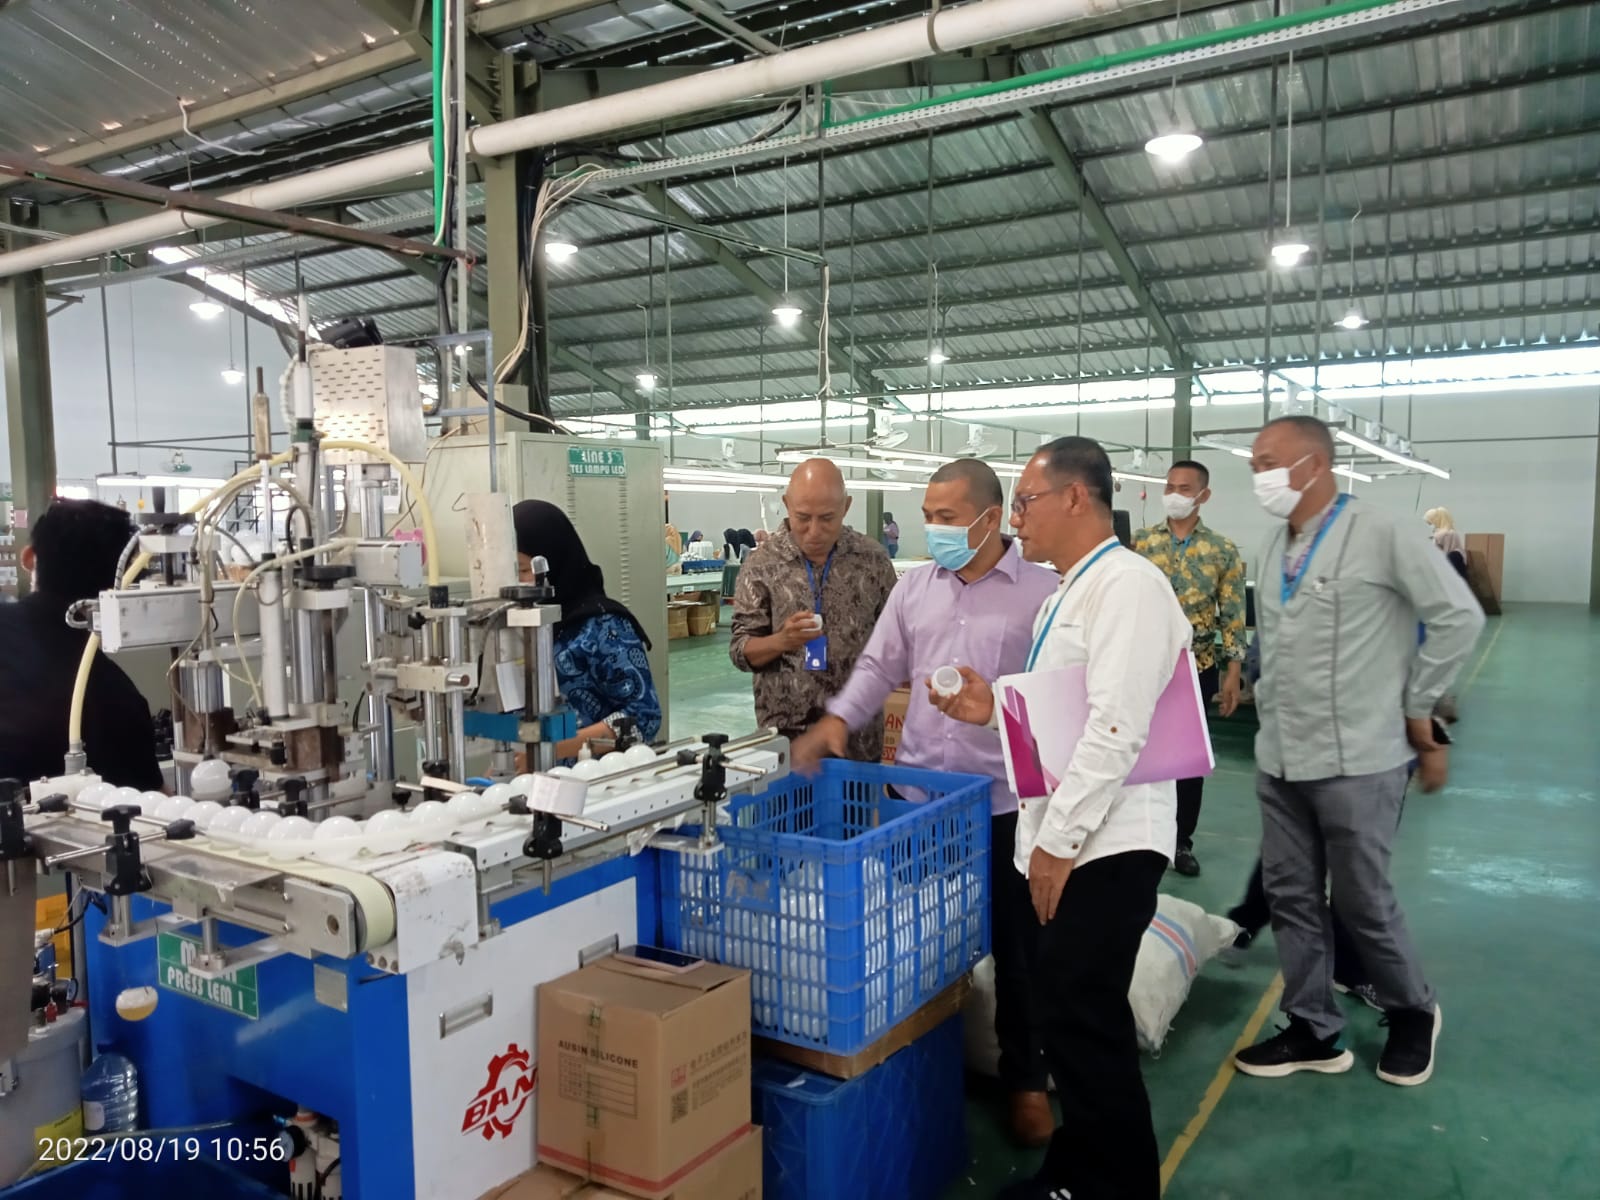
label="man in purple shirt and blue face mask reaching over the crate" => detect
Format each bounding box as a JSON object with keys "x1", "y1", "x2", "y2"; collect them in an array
[{"x1": 794, "y1": 458, "x2": 1059, "y2": 1146}]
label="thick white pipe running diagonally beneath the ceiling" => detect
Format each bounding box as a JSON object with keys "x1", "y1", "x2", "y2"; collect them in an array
[{"x1": 0, "y1": 0, "x2": 1133, "y2": 278}]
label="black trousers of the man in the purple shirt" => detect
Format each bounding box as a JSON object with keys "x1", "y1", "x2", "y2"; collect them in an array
[{"x1": 989, "y1": 813, "x2": 1050, "y2": 1091}]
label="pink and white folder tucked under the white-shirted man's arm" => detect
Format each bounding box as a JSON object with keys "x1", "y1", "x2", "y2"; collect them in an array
[{"x1": 995, "y1": 650, "x2": 1216, "y2": 800}]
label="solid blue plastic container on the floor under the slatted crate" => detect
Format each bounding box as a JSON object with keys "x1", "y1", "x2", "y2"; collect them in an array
[{"x1": 754, "y1": 1018, "x2": 966, "y2": 1200}]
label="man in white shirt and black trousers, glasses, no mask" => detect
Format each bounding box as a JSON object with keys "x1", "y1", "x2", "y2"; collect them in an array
[{"x1": 928, "y1": 437, "x2": 1194, "y2": 1200}]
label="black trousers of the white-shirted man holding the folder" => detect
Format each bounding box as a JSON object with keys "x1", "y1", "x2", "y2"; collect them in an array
[{"x1": 1034, "y1": 850, "x2": 1166, "y2": 1200}]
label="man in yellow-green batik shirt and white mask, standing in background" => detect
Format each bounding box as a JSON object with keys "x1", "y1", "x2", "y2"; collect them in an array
[{"x1": 1133, "y1": 459, "x2": 1245, "y2": 875}]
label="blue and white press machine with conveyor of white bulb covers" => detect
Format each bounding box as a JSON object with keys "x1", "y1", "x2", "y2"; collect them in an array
[{"x1": 0, "y1": 347, "x2": 789, "y2": 1200}]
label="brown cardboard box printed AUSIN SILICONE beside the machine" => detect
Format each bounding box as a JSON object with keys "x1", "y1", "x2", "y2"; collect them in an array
[{"x1": 539, "y1": 958, "x2": 750, "y2": 1200}]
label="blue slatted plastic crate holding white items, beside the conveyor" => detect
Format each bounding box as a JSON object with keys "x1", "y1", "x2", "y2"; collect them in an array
[{"x1": 661, "y1": 760, "x2": 990, "y2": 1054}]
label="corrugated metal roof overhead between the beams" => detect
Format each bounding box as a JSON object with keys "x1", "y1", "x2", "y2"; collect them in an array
[{"x1": 15, "y1": 0, "x2": 1600, "y2": 411}]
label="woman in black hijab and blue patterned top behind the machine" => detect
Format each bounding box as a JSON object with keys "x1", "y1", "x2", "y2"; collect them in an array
[{"x1": 512, "y1": 501, "x2": 661, "y2": 758}]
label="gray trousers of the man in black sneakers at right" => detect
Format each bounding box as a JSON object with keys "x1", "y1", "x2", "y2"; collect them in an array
[{"x1": 1256, "y1": 766, "x2": 1434, "y2": 1037}]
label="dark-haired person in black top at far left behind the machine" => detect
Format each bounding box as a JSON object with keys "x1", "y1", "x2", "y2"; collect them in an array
[{"x1": 0, "y1": 499, "x2": 163, "y2": 792}]
